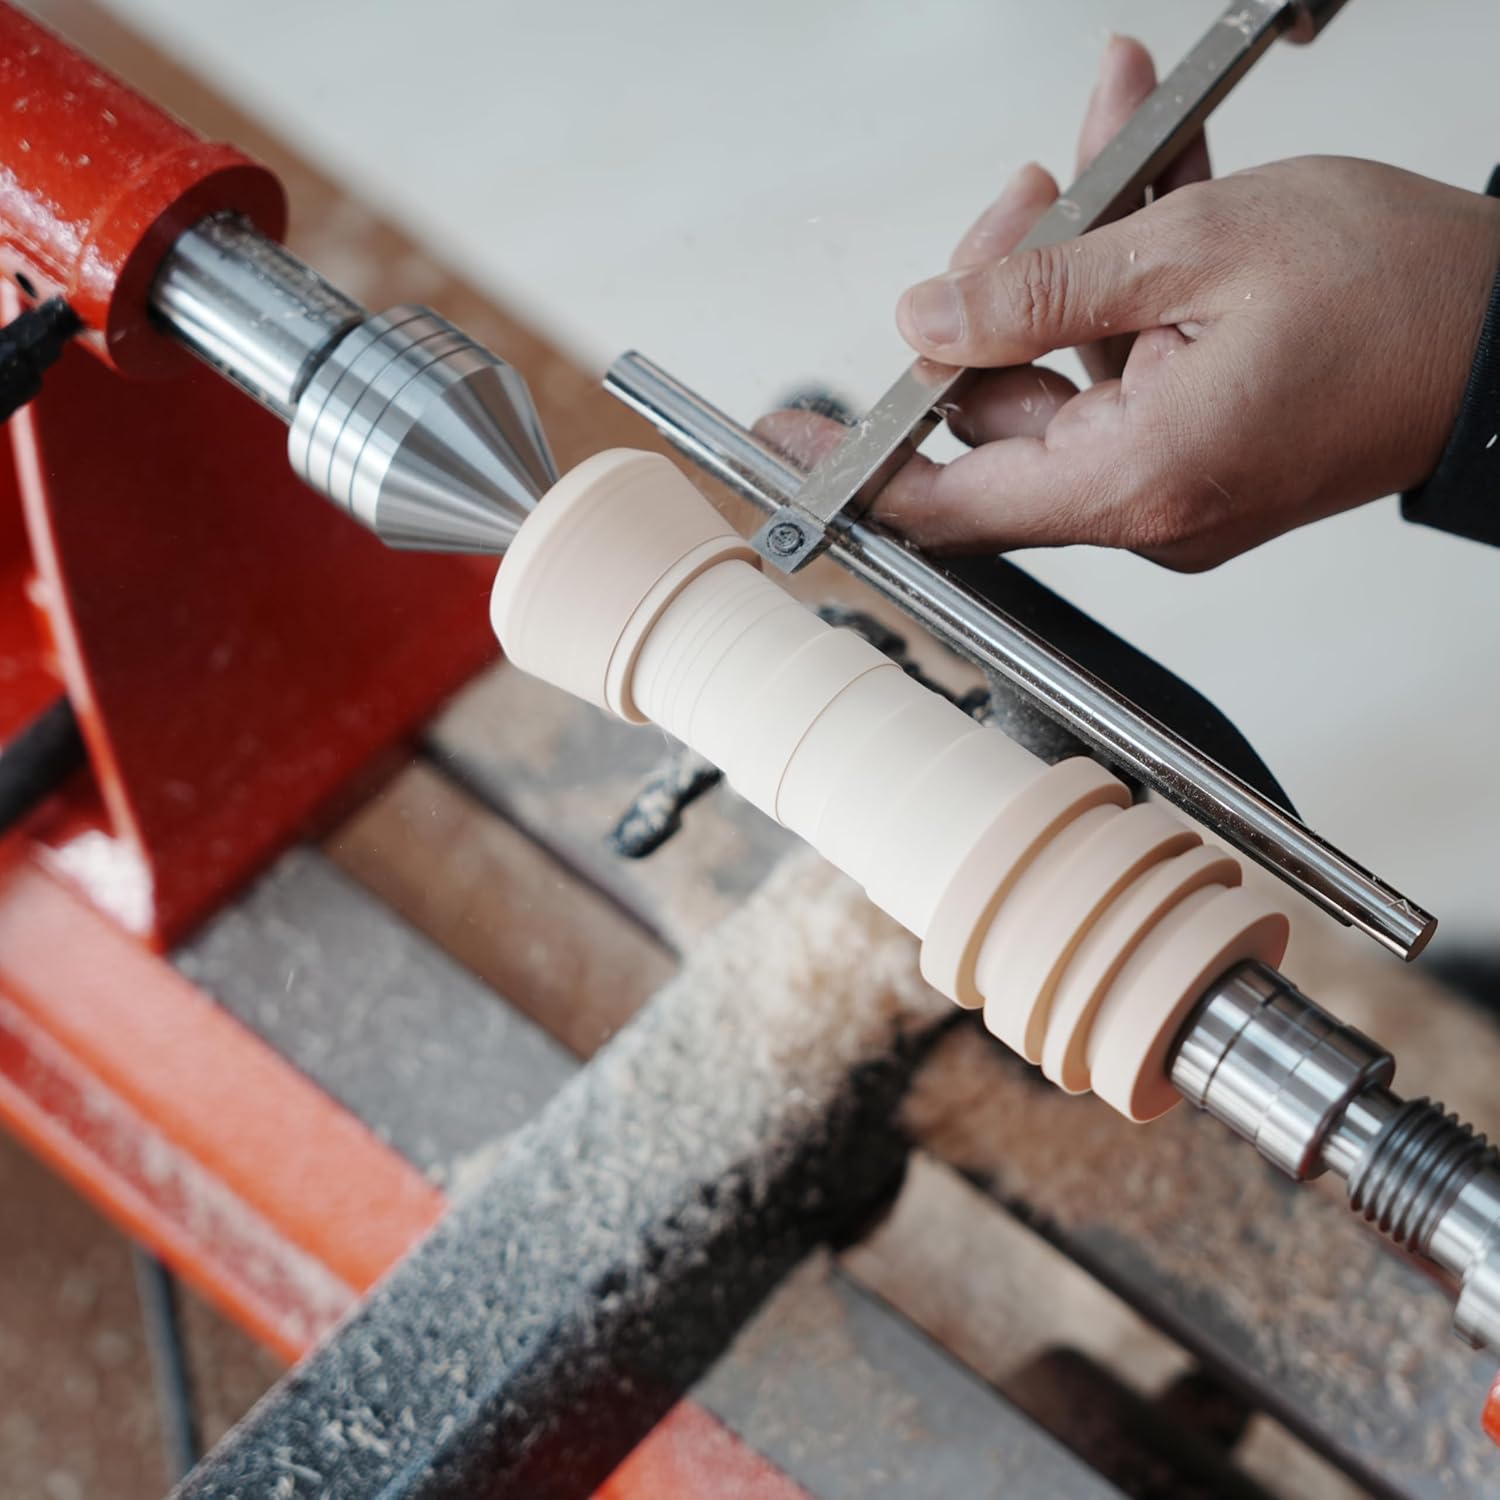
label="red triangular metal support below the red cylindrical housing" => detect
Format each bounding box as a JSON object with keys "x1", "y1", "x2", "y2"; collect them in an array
[{"x1": 0, "y1": 305, "x2": 494, "y2": 944}]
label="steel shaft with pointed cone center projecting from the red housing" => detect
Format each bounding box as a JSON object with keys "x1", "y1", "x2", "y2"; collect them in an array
[{"x1": 152, "y1": 218, "x2": 557, "y2": 552}]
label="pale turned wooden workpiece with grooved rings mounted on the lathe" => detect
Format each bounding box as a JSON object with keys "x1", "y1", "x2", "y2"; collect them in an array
[{"x1": 492, "y1": 449, "x2": 1289, "y2": 1121}]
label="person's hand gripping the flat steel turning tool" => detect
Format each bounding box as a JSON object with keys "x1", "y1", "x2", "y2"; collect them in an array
[{"x1": 759, "y1": 39, "x2": 1500, "y2": 570}]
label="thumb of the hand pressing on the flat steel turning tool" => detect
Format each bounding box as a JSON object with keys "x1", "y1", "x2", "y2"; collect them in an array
[{"x1": 896, "y1": 205, "x2": 1212, "y2": 366}]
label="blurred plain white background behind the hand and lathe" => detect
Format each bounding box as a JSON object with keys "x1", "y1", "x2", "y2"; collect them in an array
[{"x1": 36, "y1": 0, "x2": 1500, "y2": 941}]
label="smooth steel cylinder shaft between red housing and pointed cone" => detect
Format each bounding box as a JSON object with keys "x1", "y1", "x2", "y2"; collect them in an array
[{"x1": 152, "y1": 216, "x2": 365, "y2": 422}]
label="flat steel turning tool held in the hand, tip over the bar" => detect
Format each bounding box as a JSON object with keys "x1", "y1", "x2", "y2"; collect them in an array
[{"x1": 752, "y1": 0, "x2": 1290, "y2": 573}]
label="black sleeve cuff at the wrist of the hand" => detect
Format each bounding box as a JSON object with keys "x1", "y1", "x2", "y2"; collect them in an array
[{"x1": 1401, "y1": 167, "x2": 1500, "y2": 546}]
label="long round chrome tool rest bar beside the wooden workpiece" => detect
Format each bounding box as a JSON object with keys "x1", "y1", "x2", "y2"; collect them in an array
[{"x1": 605, "y1": 354, "x2": 1437, "y2": 959}]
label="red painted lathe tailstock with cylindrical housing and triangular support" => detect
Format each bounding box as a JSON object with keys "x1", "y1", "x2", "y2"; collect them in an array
[{"x1": 0, "y1": 0, "x2": 494, "y2": 944}]
